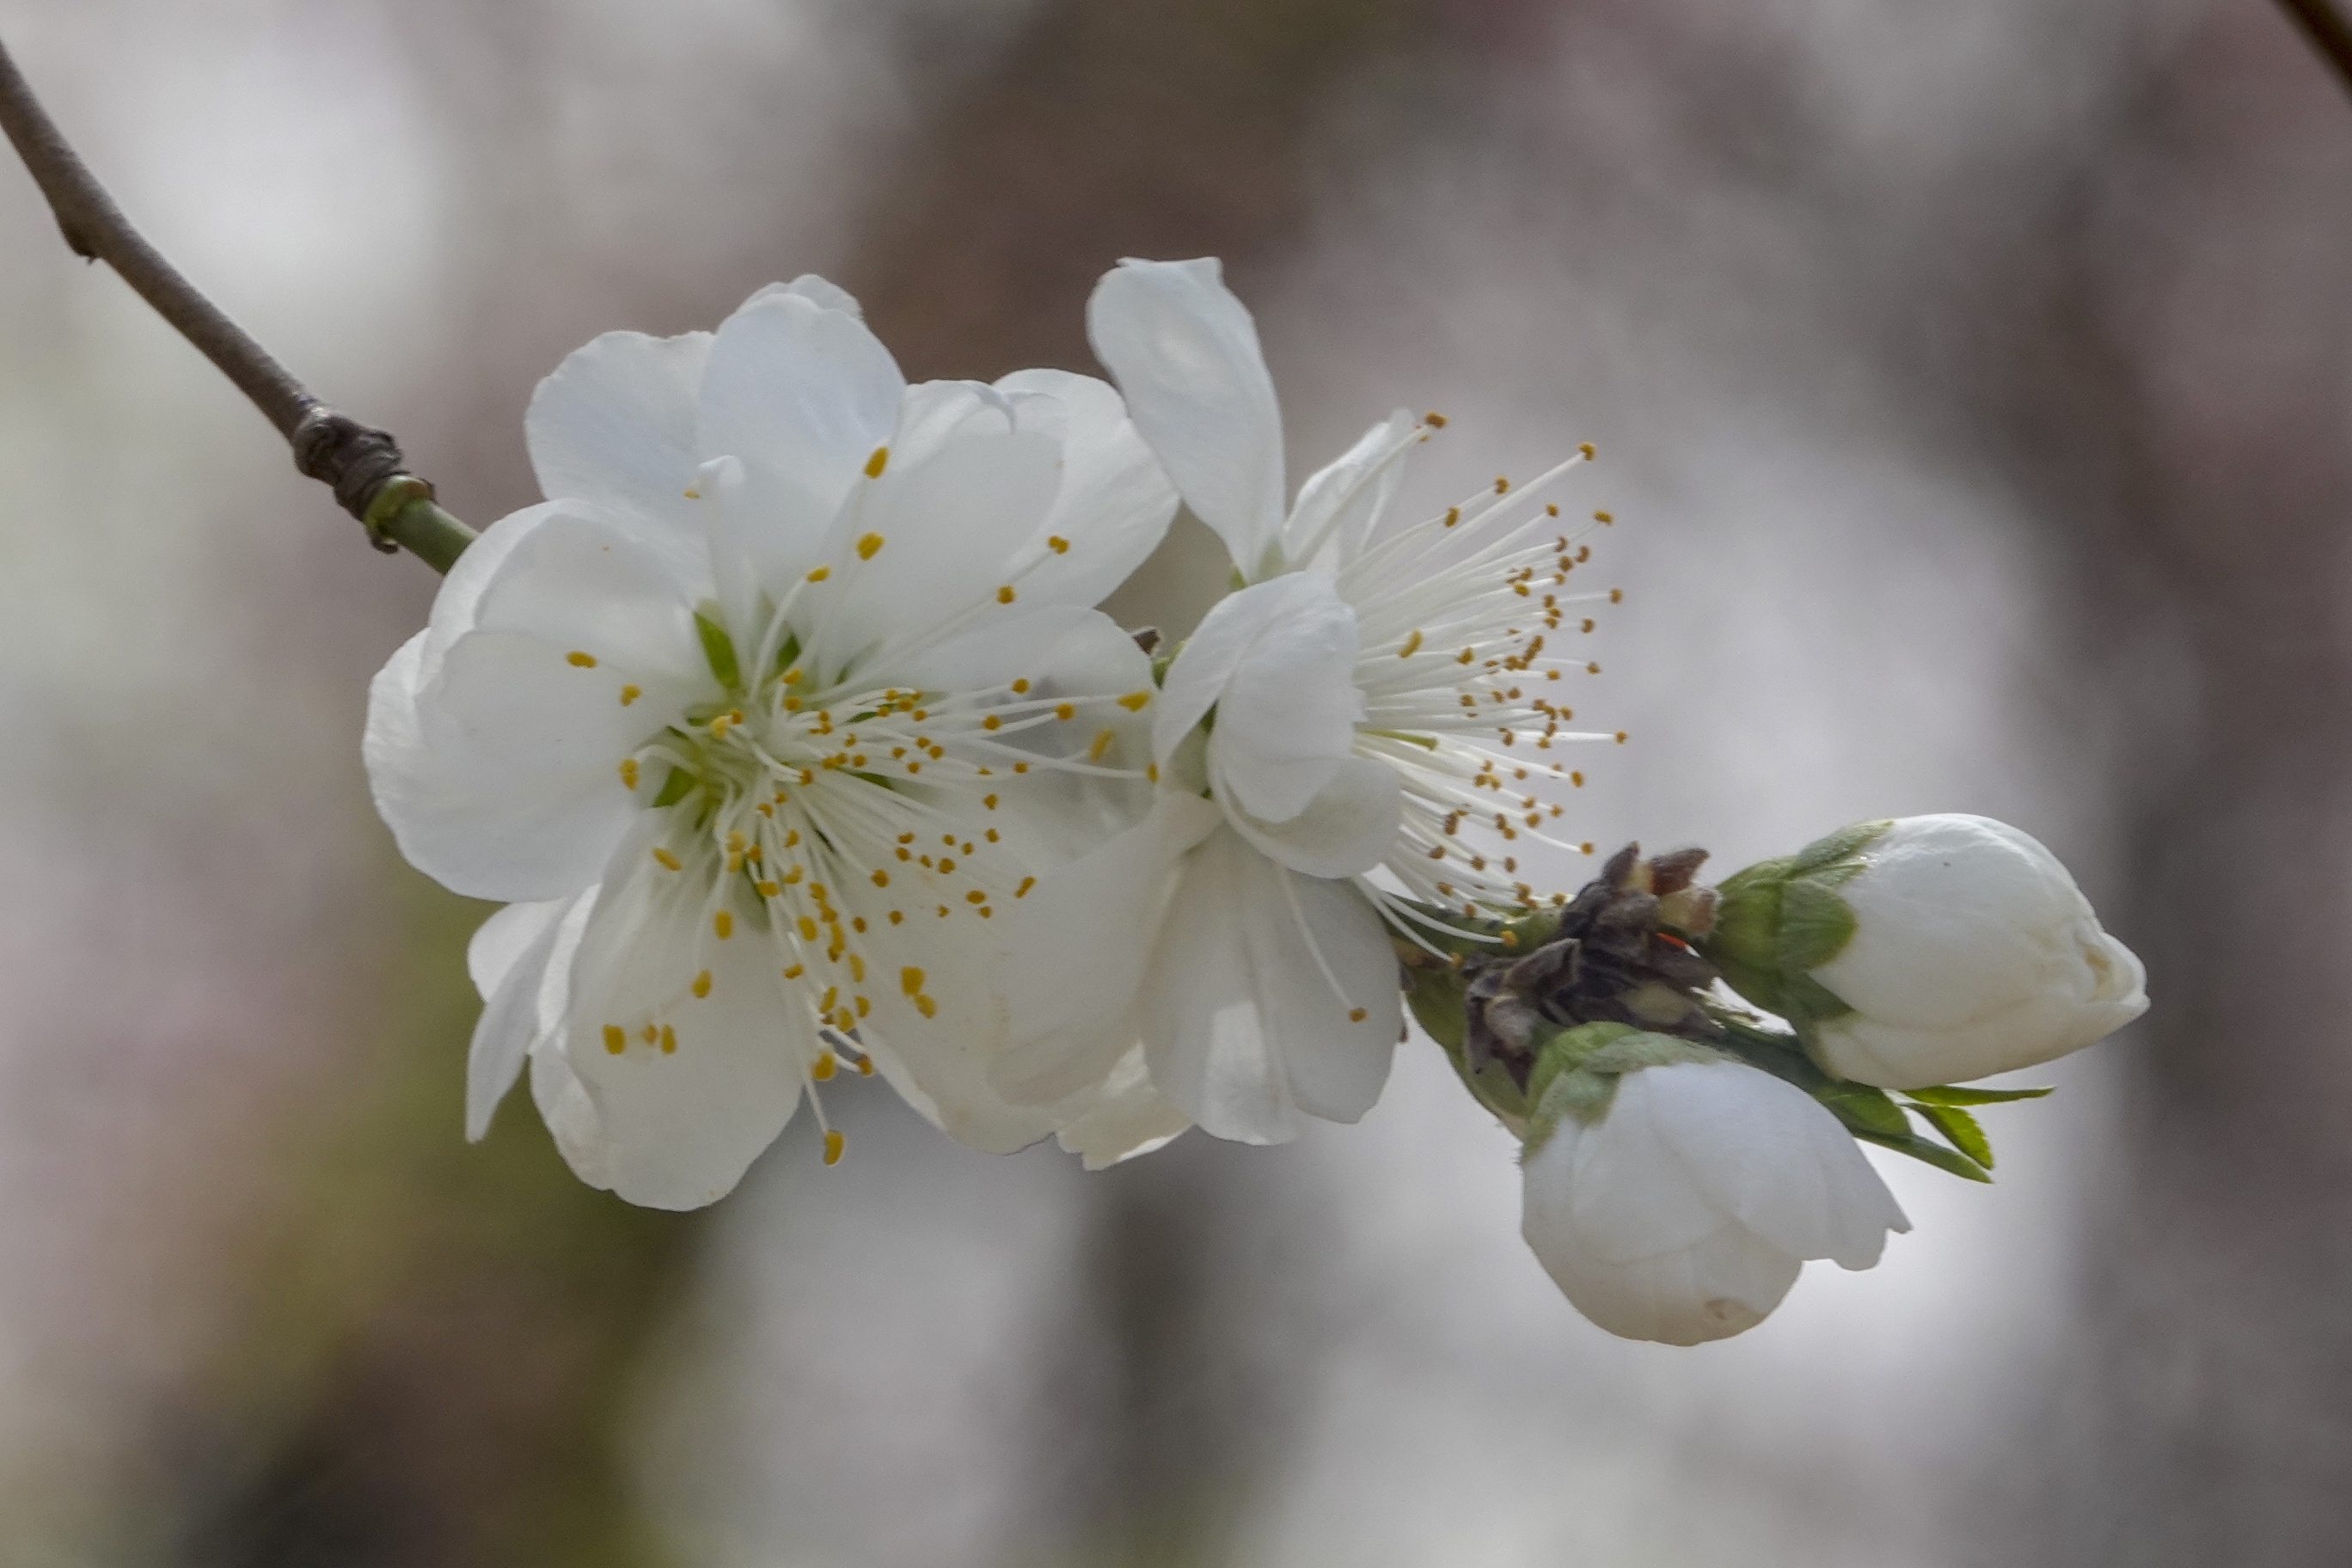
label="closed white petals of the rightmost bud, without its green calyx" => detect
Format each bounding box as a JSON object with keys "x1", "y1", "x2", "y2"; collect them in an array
[{"x1": 1809, "y1": 816, "x2": 2147, "y2": 1088}]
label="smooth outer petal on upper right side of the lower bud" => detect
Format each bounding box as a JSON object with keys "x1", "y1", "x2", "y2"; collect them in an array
[{"x1": 1646, "y1": 1063, "x2": 1910, "y2": 1270}]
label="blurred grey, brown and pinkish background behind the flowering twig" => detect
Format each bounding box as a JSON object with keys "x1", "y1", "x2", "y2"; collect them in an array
[{"x1": 0, "y1": 0, "x2": 2352, "y2": 1568}]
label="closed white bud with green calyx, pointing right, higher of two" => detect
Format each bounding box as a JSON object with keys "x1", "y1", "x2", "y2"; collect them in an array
[{"x1": 1707, "y1": 816, "x2": 2147, "y2": 1088}]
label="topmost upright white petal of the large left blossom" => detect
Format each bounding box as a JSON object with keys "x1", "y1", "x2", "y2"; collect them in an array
[{"x1": 694, "y1": 289, "x2": 905, "y2": 583}]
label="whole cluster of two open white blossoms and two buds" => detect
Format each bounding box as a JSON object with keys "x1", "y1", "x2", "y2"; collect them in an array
[{"x1": 367, "y1": 261, "x2": 2145, "y2": 1342}]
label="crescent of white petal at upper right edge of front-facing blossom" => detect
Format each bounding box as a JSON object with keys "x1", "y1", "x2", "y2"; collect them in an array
[{"x1": 997, "y1": 369, "x2": 1176, "y2": 604}]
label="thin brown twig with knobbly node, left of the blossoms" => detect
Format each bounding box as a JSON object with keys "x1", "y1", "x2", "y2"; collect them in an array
[{"x1": 0, "y1": 34, "x2": 473, "y2": 572}]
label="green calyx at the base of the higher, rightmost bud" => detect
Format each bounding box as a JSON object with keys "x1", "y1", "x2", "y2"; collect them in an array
[{"x1": 1700, "y1": 820, "x2": 1893, "y2": 1032}]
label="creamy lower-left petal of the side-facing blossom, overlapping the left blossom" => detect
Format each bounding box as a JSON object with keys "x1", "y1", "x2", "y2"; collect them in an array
[{"x1": 990, "y1": 790, "x2": 1221, "y2": 1105}]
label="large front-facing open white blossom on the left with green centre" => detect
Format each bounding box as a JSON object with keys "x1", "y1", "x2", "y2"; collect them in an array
[{"x1": 367, "y1": 278, "x2": 1180, "y2": 1209}]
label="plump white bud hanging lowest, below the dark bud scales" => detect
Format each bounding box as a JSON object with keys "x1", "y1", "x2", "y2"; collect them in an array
[{"x1": 1519, "y1": 1044, "x2": 1910, "y2": 1344}]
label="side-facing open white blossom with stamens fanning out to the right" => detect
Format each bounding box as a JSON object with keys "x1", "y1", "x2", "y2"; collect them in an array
[{"x1": 995, "y1": 261, "x2": 1616, "y2": 1142}]
